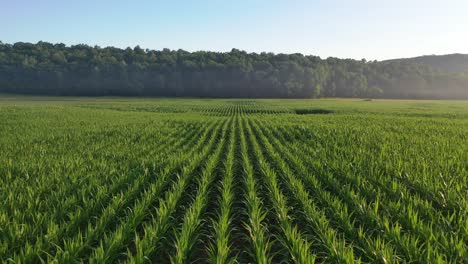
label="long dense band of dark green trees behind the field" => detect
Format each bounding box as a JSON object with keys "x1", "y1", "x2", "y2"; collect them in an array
[{"x1": 0, "y1": 42, "x2": 468, "y2": 99}]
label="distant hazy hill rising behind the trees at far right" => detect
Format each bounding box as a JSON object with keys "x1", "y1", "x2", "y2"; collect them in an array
[{"x1": 388, "y1": 53, "x2": 468, "y2": 73}]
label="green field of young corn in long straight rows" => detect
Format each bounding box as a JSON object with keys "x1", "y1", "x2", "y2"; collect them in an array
[{"x1": 0, "y1": 95, "x2": 468, "y2": 263}]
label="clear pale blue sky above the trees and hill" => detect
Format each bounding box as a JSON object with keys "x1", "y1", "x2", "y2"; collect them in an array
[{"x1": 0, "y1": 0, "x2": 468, "y2": 60}]
